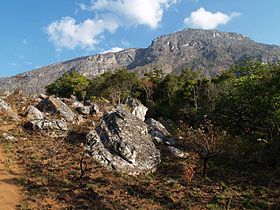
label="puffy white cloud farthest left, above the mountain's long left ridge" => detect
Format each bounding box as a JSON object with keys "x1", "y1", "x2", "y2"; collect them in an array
[{"x1": 45, "y1": 17, "x2": 118, "y2": 51}]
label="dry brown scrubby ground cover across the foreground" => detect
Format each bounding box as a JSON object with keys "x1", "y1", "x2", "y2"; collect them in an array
[{"x1": 0, "y1": 94, "x2": 280, "y2": 209}]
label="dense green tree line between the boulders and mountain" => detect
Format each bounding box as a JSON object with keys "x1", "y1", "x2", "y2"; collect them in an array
[{"x1": 46, "y1": 62, "x2": 280, "y2": 164}]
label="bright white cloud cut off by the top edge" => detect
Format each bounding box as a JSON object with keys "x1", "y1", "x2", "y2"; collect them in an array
[{"x1": 90, "y1": 0, "x2": 176, "y2": 29}]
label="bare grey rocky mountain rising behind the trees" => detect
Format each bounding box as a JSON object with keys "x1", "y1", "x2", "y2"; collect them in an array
[{"x1": 0, "y1": 29, "x2": 280, "y2": 93}]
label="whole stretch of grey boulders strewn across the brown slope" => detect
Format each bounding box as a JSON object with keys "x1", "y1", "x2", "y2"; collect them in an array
[{"x1": 0, "y1": 94, "x2": 188, "y2": 175}]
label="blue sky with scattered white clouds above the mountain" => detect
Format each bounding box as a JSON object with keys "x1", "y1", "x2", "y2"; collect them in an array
[{"x1": 0, "y1": 0, "x2": 280, "y2": 77}]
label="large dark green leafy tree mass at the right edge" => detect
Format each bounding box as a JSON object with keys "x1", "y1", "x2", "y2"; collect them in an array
[{"x1": 212, "y1": 63, "x2": 280, "y2": 165}]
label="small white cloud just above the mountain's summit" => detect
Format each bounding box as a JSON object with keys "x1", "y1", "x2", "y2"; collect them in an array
[{"x1": 184, "y1": 7, "x2": 240, "y2": 29}]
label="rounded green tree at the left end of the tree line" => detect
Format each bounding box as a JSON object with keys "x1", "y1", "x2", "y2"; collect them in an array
[{"x1": 46, "y1": 71, "x2": 89, "y2": 100}]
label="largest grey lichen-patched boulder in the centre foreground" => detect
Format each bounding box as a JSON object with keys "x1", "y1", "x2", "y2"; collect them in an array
[{"x1": 87, "y1": 106, "x2": 160, "y2": 175}]
